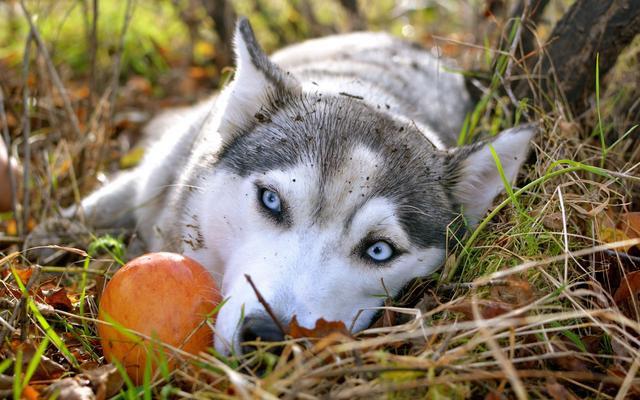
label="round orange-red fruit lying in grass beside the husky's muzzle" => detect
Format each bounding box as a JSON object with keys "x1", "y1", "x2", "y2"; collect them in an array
[{"x1": 98, "y1": 253, "x2": 221, "y2": 384}]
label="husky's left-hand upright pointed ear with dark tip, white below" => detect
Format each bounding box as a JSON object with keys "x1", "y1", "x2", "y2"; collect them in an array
[{"x1": 217, "y1": 17, "x2": 300, "y2": 139}]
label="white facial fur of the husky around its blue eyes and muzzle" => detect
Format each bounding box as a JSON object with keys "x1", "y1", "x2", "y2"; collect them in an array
[{"x1": 186, "y1": 148, "x2": 444, "y2": 352}]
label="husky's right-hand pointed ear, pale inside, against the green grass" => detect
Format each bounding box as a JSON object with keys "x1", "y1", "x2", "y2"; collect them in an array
[{"x1": 447, "y1": 125, "x2": 537, "y2": 225}]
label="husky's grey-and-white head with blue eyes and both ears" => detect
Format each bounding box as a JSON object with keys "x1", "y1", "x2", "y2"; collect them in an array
[{"x1": 182, "y1": 21, "x2": 532, "y2": 352}]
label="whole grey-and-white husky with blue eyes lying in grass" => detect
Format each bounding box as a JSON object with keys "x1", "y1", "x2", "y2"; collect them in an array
[{"x1": 72, "y1": 19, "x2": 534, "y2": 352}]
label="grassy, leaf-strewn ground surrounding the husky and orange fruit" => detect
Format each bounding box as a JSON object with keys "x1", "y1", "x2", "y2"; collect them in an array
[{"x1": 0, "y1": 0, "x2": 640, "y2": 399}]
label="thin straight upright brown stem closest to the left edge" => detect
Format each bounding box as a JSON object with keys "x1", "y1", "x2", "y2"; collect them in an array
[{"x1": 18, "y1": 29, "x2": 33, "y2": 241}]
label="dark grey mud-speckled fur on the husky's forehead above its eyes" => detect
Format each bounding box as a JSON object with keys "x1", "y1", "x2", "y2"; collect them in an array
[{"x1": 217, "y1": 97, "x2": 453, "y2": 247}]
